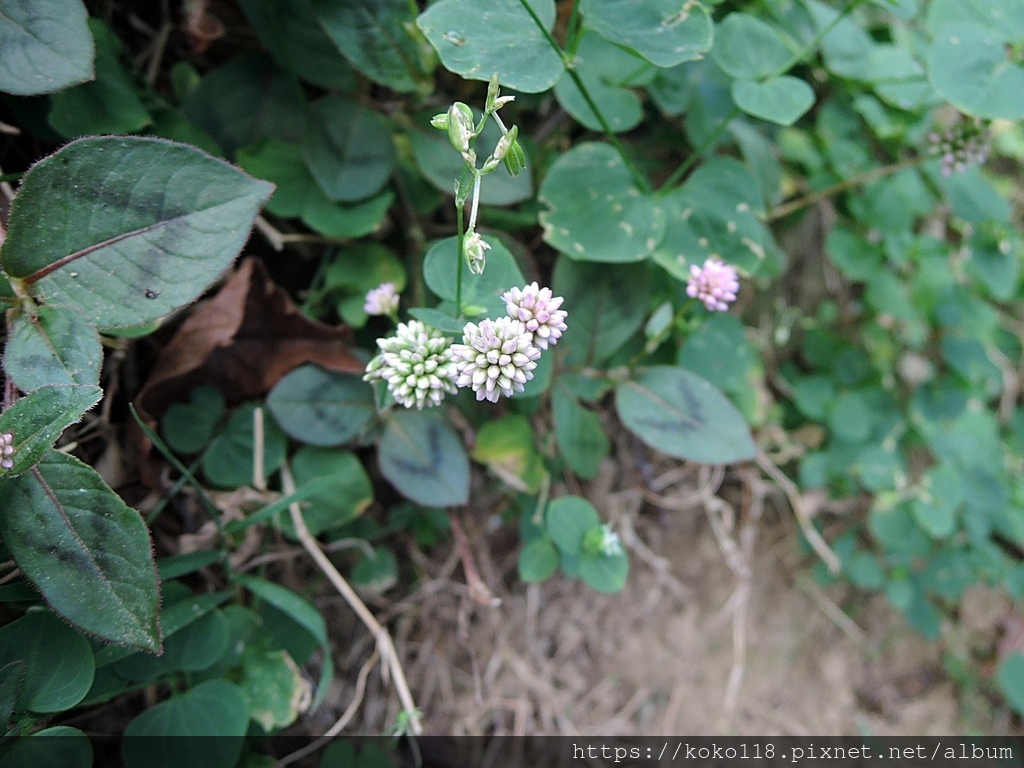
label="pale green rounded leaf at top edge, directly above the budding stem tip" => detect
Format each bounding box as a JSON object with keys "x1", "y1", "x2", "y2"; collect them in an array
[{"x1": 416, "y1": 0, "x2": 565, "y2": 93}]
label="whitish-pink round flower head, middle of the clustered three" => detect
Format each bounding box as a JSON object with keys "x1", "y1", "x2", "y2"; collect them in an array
[{"x1": 452, "y1": 317, "x2": 541, "y2": 402}]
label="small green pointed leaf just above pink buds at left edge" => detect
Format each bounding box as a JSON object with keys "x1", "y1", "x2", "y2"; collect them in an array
[{"x1": 0, "y1": 386, "x2": 102, "y2": 477}]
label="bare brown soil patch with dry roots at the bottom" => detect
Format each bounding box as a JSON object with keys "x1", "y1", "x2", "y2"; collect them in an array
[{"x1": 309, "y1": 460, "x2": 1012, "y2": 736}]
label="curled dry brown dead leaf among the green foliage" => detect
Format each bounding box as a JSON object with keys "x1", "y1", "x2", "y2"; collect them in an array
[{"x1": 135, "y1": 258, "x2": 365, "y2": 484}]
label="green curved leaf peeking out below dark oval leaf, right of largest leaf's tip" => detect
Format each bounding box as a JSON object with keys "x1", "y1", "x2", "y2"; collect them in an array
[{"x1": 238, "y1": 138, "x2": 394, "y2": 240}]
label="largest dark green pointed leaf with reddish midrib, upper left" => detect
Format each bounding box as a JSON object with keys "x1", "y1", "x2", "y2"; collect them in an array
[{"x1": 0, "y1": 138, "x2": 272, "y2": 329}]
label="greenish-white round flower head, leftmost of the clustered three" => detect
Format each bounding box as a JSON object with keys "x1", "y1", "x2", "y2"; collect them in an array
[{"x1": 362, "y1": 321, "x2": 457, "y2": 409}]
